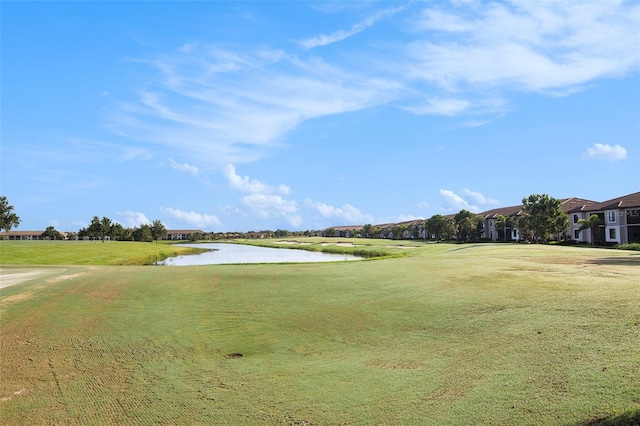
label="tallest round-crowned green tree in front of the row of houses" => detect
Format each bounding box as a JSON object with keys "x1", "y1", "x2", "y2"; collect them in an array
[{"x1": 522, "y1": 194, "x2": 569, "y2": 243}]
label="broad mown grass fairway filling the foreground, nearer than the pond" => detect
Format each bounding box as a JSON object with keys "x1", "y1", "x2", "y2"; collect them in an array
[{"x1": 0, "y1": 240, "x2": 640, "y2": 426}]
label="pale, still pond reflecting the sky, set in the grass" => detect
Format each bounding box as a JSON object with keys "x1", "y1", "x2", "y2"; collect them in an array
[{"x1": 158, "y1": 243, "x2": 362, "y2": 266}]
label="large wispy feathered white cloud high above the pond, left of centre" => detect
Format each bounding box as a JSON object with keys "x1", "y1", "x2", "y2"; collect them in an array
[{"x1": 109, "y1": 43, "x2": 402, "y2": 167}]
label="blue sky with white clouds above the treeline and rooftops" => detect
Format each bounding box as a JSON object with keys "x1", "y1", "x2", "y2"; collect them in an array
[{"x1": 0, "y1": 1, "x2": 640, "y2": 231}]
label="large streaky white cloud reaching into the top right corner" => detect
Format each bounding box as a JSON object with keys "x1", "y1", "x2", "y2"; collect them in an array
[{"x1": 408, "y1": 1, "x2": 640, "y2": 94}]
